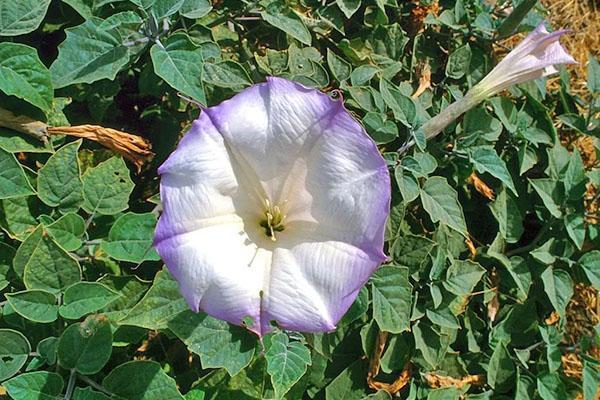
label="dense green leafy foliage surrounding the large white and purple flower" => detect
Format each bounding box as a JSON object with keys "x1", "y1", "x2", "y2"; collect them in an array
[{"x1": 0, "y1": 0, "x2": 600, "y2": 400}]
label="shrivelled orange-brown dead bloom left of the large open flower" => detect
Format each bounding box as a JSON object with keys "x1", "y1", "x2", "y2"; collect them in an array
[{"x1": 48, "y1": 125, "x2": 154, "y2": 172}]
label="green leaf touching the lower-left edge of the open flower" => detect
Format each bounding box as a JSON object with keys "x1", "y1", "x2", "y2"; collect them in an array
[{"x1": 119, "y1": 269, "x2": 188, "y2": 329}]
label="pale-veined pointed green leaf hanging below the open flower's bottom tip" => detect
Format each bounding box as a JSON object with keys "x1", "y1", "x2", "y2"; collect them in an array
[{"x1": 265, "y1": 332, "x2": 311, "y2": 399}]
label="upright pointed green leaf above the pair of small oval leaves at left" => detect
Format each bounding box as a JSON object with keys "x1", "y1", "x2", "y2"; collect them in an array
[{"x1": 13, "y1": 225, "x2": 81, "y2": 292}]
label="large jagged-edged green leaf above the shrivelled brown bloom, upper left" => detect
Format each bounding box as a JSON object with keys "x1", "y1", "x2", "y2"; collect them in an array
[{"x1": 50, "y1": 17, "x2": 129, "y2": 88}]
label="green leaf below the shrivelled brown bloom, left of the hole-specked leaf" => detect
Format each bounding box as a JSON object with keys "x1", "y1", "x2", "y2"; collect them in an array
[{"x1": 37, "y1": 140, "x2": 83, "y2": 212}]
